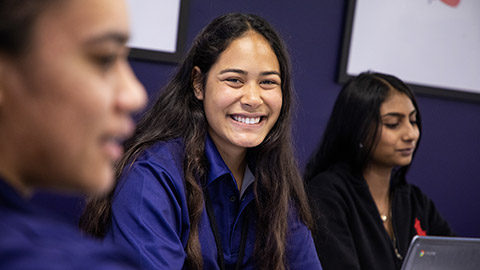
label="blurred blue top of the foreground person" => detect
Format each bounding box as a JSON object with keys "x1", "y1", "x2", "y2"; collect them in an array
[{"x1": 0, "y1": 179, "x2": 138, "y2": 270}]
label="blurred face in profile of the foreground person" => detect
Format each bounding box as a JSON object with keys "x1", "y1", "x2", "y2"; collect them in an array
[{"x1": 0, "y1": 0, "x2": 146, "y2": 195}]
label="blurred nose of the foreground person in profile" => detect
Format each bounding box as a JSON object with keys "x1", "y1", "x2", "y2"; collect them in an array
[{"x1": 117, "y1": 62, "x2": 147, "y2": 113}]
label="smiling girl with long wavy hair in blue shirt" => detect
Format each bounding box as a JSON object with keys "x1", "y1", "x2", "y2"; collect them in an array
[{"x1": 82, "y1": 14, "x2": 321, "y2": 269}]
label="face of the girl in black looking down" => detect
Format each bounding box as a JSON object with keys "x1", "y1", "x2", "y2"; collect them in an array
[{"x1": 370, "y1": 90, "x2": 420, "y2": 169}]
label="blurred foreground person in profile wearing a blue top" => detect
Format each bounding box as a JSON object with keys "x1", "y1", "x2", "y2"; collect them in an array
[{"x1": 0, "y1": 0, "x2": 146, "y2": 269}]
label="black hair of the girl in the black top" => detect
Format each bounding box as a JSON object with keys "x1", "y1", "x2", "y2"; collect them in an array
[{"x1": 304, "y1": 72, "x2": 422, "y2": 181}]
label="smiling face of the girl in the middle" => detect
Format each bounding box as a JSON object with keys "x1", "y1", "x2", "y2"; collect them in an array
[{"x1": 194, "y1": 31, "x2": 282, "y2": 156}]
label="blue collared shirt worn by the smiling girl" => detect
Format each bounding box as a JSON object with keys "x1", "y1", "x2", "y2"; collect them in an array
[{"x1": 106, "y1": 136, "x2": 321, "y2": 269}]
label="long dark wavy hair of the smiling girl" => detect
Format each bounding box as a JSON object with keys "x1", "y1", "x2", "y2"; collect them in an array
[{"x1": 80, "y1": 13, "x2": 312, "y2": 269}]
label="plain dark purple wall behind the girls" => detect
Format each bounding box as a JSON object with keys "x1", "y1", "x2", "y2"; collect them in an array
[{"x1": 132, "y1": 0, "x2": 480, "y2": 237}]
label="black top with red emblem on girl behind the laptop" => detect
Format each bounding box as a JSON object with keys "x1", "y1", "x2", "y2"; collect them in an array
[{"x1": 307, "y1": 164, "x2": 454, "y2": 270}]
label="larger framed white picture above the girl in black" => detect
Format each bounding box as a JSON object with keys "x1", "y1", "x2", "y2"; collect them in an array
[{"x1": 338, "y1": 0, "x2": 480, "y2": 101}]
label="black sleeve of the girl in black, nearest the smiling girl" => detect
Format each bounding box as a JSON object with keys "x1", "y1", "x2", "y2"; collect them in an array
[{"x1": 307, "y1": 173, "x2": 360, "y2": 270}]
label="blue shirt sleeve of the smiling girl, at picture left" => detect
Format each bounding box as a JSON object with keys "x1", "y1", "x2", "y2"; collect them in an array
[{"x1": 106, "y1": 160, "x2": 189, "y2": 269}]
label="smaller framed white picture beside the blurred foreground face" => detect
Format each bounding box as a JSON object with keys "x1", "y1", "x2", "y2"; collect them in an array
[{"x1": 127, "y1": 0, "x2": 189, "y2": 63}]
